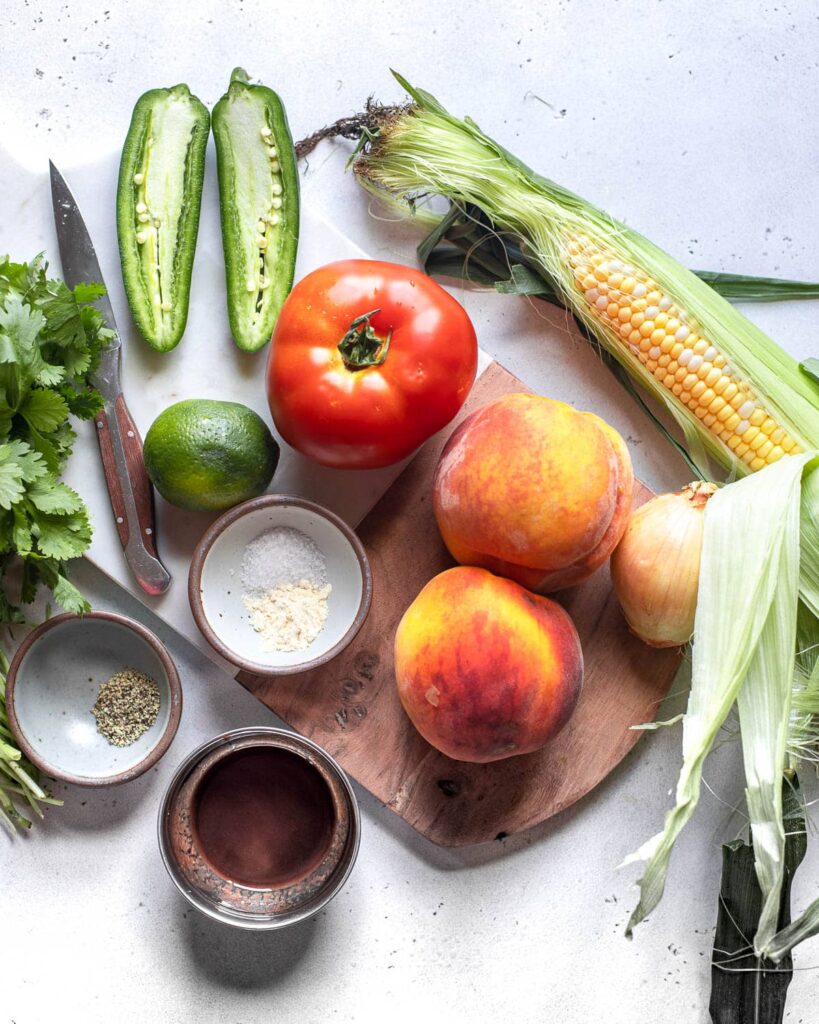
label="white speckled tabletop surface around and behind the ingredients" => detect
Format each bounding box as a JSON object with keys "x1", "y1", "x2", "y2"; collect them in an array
[{"x1": 0, "y1": 0, "x2": 819, "y2": 1024}]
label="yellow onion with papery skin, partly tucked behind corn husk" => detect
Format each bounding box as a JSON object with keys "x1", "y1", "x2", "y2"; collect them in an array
[{"x1": 611, "y1": 480, "x2": 717, "y2": 647}]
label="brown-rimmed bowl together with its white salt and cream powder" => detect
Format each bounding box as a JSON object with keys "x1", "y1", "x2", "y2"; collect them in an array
[{"x1": 187, "y1": 495, "x2": 373, "y2": 676}]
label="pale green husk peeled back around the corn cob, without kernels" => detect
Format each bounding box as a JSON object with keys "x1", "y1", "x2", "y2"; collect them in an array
[{"x1": 353, "y1": 75, "x2": 819, "y2": 956}]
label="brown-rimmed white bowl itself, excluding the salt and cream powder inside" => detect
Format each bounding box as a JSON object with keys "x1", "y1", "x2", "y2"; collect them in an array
[{"x1": 187, "y1": 495, "x2": 373, "y2": 676}]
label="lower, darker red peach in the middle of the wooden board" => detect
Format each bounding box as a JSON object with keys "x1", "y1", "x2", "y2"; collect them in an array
[{"x1": 395, "y1": 566, "x2": 583, "y2": 762}]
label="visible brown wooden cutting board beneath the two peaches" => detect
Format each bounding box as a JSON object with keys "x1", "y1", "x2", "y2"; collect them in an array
[{"x1": 236, "y1": 364, "x2": 680, "y2": 846}]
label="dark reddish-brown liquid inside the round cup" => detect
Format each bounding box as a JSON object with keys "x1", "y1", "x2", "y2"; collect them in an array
[{"x1": 193, "y1": 746, "x2": 336, "y2": 889}]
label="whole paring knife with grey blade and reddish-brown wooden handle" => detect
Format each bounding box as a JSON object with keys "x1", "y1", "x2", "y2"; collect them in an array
[{"x1": 48, "y1": 160, "x2": 171, "y2": 595}]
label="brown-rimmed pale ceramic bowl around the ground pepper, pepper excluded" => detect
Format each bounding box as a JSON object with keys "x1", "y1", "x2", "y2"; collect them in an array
[{"x1": 6, "y1": 611, "x2": 182, "y2": 785}]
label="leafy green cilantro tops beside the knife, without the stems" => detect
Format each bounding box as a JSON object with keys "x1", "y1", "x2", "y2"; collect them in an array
[{"x1": 0, "y1": 255, "x2": 113, "y2": 622}]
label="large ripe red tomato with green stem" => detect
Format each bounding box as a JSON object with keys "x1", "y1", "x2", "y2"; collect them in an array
[{"x1": 267, "y1": 259, "x2": 478, "y2": 469}]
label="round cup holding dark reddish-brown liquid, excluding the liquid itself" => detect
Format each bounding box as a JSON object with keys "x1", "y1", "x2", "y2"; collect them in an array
[{"x1": 158, "y1": 726, "x2": 361, "y2": 931}]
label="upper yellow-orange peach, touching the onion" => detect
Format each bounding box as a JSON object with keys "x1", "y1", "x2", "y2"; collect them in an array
[{"x1": 433, "y1": 394, "x2": 634, "y2": 593}]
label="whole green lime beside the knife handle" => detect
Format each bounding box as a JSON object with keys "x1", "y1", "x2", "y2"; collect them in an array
[{"x1": 144, "y1": 398, "x2": 278, "y2": 512}]
